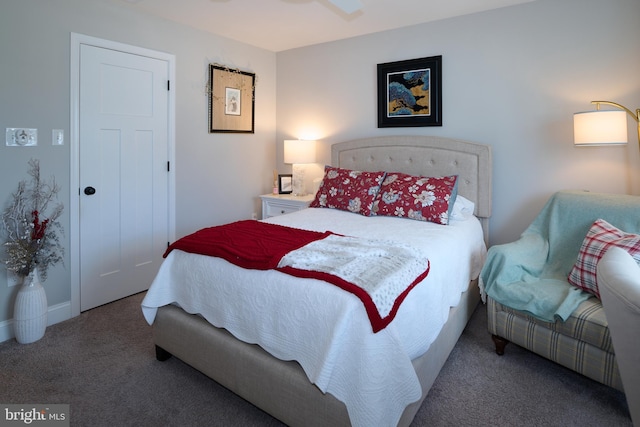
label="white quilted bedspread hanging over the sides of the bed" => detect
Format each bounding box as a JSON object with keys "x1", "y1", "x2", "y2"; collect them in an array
[{"x1": 142, "y1": 209, "x2": 486, "y2": 426}]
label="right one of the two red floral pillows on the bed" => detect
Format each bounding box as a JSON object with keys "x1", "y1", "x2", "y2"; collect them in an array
[{"x1": 373, "y1": 173, "x2": 458, "y2": 225}]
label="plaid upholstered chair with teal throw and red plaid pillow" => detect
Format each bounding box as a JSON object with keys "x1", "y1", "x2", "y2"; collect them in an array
[{"x1": 480, "y1": 191, "x2": 640, "y2": 390}]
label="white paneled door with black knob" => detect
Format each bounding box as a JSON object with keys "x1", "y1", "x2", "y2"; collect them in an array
[{"x1": 79, "y1": 45, "x2": 169, "y2": 311}]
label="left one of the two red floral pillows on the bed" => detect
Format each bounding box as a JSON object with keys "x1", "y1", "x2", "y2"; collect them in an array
[{"x1": 309, "y1": 166, "x2": 385, "y2": 216}]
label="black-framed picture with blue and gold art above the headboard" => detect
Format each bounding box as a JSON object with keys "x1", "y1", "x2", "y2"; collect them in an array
[{"x1": 378, "y1": 55, "x2": 442, "y2": 128}]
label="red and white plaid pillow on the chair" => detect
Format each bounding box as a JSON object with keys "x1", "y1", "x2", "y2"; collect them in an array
[{"x1": 569, "y1": 219, "x2": 640, "y2": 298}]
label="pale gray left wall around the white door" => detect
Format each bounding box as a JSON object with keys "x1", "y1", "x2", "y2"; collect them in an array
[{"x1": 0, "y1": 0, "x2": 276, "y2": 328}]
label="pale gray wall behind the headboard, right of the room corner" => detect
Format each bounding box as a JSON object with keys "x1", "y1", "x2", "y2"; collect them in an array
[{"x1": 277, "y1": 0, "x2": 640, "y2": 244}]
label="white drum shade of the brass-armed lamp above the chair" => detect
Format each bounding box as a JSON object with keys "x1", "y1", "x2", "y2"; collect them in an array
[{"x1": 573, "y1": 111, "x2": 628, "y2": 145}]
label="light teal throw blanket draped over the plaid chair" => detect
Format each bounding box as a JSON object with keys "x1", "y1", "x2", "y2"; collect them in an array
[{"x1": 480, "y1": 191, "x2": 640, "y2": 322}]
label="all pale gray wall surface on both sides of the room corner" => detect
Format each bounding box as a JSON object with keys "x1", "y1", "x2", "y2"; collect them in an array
[{"x1": 0, "y1": 0, "x2": 640, "y2": 329}]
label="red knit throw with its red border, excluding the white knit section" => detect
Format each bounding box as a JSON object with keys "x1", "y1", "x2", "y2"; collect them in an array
[{"x1": 163, "y1": 220, "x2": 429, "y2": 333}]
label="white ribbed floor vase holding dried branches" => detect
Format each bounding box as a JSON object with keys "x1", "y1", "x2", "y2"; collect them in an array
[{"x1": 13, "y1": 268, "x2": 48, "y2": 344}]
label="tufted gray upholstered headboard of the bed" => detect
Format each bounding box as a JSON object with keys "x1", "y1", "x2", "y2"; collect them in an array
[{"x1": 331, "y1": 136, "x2": 492, "y2": 241}]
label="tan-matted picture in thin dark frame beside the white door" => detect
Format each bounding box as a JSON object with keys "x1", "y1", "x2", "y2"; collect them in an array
[{"x1": 208, "y1": 64, "x2": 256, "y2": 133}]
